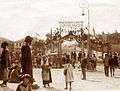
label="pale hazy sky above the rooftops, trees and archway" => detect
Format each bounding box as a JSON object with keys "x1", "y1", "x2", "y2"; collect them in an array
[{"x1": 0, "y1": 0, "x2": 120, "y2": 41}]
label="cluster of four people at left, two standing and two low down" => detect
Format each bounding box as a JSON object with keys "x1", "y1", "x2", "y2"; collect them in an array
[{"x1": 0, "y1": 36, "x2": 35, "y2": 91}]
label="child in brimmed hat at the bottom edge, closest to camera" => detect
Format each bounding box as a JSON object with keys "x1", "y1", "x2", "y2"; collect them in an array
[{"x1": 16, "y1": 74, "x2": 32, "y2": 91}]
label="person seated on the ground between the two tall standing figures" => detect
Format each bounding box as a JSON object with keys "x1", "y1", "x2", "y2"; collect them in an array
[{"x1": 9, "y1": 65, "x2": 22, "y2": 83}]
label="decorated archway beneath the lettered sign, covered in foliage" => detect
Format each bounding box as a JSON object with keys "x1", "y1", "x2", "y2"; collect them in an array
[{"x1": 52, "y1": 31, "x2": 87, "y2": 53}]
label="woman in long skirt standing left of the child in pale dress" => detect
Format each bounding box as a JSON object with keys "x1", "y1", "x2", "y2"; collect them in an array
[{"x1": 42, "y1": 56, "x2": 52, "y2": 87}]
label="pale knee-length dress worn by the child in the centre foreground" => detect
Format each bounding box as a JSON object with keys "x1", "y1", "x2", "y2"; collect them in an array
[{"x1": 64, "y1": 63, "x2": 74, "y2": 82}]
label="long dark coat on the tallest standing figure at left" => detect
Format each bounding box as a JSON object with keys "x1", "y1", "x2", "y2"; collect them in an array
[{"x1": 21, "y1": 45, "x2": 33, "y2": 77}]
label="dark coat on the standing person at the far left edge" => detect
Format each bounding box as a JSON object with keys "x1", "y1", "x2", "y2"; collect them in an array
[{"x1": 1, "y1": 50, "x2": 10, "y2": 68}]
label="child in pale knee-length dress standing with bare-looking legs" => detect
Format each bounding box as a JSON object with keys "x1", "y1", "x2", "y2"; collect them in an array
[{"x1": 64, "y1": 57, "x2": 74, "y2": 90}]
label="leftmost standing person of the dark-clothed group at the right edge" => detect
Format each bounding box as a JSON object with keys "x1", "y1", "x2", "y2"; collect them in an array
[{"x1": 103, "y1": 54, "x2": 109, "y2": 77}]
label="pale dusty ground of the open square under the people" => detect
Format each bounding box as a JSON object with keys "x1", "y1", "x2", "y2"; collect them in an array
[{"x1": 0, "y1": 66, "x2": 120, "y2": 91}]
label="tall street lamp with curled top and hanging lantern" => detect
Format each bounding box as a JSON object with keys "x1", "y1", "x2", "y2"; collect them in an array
[{"x1": 79, "y1": 0, "x2": 91, "y2": 56}]
